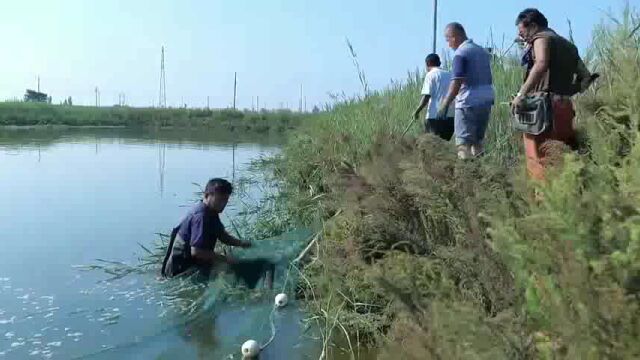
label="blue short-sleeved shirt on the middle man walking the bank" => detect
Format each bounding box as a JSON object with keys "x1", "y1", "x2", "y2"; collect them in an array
[{"x1": 453, "y1": 40, "x2": 495, "y2": 109}]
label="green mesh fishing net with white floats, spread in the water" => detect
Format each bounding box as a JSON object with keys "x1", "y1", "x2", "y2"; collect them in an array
[{"x1": 83, "y1": 229, "x2": 319, "y2": 359}]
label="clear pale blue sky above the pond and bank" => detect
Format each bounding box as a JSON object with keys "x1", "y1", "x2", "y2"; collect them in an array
[{"x1": 0, "y1": 0, "x2": 640, "y2": 108}]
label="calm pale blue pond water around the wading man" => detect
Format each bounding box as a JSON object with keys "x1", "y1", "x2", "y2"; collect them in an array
[{"x1": 0, "y1": 128, "x2": 330, "y2": 359}]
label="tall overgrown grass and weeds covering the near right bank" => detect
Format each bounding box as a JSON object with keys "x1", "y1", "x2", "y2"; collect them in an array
[{"x1": 276, "y1": 9, "x2": 640, "y2": 359}]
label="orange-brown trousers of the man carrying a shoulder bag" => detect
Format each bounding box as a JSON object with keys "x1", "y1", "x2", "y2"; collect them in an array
[{"x1": 523, "y1": 97, "x2": 576, "y2": 180}]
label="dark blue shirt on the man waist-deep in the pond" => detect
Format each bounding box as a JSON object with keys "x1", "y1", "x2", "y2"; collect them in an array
[{"x1": 178, "y1": 201, "x2": 225, "y2": 250}]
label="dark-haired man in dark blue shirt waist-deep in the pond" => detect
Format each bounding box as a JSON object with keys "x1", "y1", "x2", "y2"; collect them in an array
[{"x1": 162, "y1": 178, "x2": 251, "y2": 278}]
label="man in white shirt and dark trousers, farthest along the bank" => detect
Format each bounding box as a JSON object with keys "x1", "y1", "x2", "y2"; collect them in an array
[{"x1": 413, "y1": 54, "x2": 455, "y2": 141}]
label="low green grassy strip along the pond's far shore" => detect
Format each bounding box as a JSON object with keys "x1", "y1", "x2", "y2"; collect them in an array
[{"x1": 0, "y1": 102, "x2": 310, "y2": 132}]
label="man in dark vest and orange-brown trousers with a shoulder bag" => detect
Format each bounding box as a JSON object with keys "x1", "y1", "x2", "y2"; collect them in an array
[{"x1": 512, "y1": 9, "x2": 598, "y2": 180}]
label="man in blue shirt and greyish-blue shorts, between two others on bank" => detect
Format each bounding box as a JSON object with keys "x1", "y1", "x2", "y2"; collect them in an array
[{"x1": 438, "y1": 23, "x2": 495, "y2": 159}]
